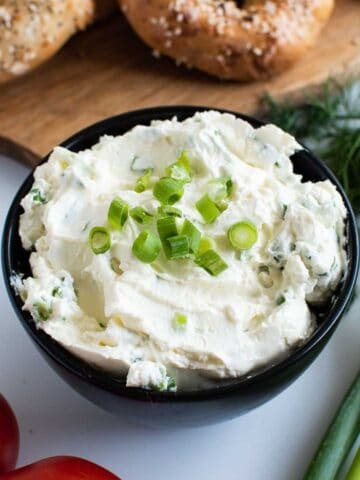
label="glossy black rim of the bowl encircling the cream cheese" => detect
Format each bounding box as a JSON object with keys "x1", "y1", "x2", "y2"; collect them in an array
[{"x1": 2, "y1": 105, "x2": 359, "y2": 402}]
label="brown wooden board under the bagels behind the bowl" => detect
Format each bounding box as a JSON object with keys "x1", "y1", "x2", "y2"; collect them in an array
[{"x1": 0, "y1": 0, "x2": 360, "y2": 163}]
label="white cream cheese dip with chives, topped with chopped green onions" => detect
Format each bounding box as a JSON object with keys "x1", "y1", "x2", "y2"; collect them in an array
[{"x1": 13, "y1": 111, "x2": 347, "y2": 390}]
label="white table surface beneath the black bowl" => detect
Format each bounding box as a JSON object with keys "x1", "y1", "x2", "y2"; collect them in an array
[{"x1": 0, "y1": 157, "x2": 360, "y2": 480}]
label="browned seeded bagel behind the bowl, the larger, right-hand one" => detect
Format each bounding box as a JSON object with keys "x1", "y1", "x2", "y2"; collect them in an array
[{"x1": 119, "y1": 0, "x2": 334, "y2": 81}]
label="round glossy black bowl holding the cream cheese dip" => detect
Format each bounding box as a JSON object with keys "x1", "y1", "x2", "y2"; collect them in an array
[{"x1": 2, "y1": 106, "x2": 359, "y2": 425}]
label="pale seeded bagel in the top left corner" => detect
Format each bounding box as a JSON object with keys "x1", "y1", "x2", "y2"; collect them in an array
[{"x1": 0, "y1": 0, "x2": 115, "y2": 84}]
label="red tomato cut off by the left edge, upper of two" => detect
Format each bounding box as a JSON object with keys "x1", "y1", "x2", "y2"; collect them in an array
[{"x1": 0, "y1": 395, "x2": 20, "y2": 475}]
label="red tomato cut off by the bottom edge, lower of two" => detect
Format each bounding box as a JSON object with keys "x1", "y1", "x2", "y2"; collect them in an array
[{"x1": 0, "y1": 457, "x2": 121, "y2": 480}]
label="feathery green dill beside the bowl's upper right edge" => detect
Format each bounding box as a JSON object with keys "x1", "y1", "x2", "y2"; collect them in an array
[{"x1": 263, "y1": 80, "x2": 360, "y2": 213}]
